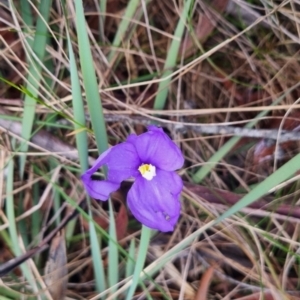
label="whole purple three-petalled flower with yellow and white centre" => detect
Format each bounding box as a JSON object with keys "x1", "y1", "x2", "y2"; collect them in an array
[{"x1": 81, "y1": 126, "x2": 184, "y2": 232}]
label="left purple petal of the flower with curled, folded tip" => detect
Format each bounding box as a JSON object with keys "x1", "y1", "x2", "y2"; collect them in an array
[{"x1": 81, "y1": 142, "x2": 141, "y2": 200}]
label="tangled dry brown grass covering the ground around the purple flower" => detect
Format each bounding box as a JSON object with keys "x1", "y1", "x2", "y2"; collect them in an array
[{"x1": 0, "y1": 0, "x2": 300, "y2": 300}]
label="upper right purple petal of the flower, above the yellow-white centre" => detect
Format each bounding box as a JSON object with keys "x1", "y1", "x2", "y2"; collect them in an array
[{"x1": 127, "y1": 126, "x2": 184, "y2": 171}]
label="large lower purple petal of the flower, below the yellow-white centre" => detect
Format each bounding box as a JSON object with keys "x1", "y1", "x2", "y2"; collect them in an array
[{"x1": 127, "y1": 169, "x2": 182, "y2": 232}]
